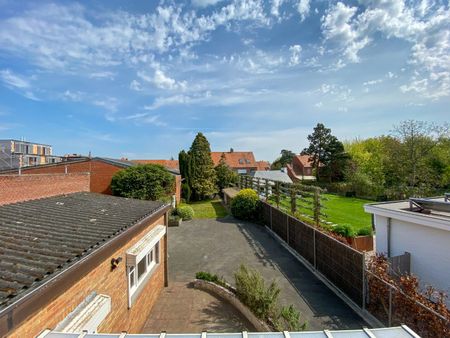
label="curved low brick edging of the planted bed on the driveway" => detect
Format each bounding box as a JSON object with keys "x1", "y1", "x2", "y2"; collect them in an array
[{"x1": 192, "y1": 279, "x2": 273, "y2": 332}]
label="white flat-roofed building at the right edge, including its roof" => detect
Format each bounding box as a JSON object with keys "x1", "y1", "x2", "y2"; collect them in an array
[{"x1": 364, "y1": 197, "x2": 450, "y2": 294}]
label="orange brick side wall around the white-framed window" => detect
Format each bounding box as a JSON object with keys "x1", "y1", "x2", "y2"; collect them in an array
[{"x1": 8, "y1": 216, "x2": 167, "y2": 338}]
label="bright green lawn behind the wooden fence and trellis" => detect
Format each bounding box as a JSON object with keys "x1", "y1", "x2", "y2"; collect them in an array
[{"x1": 272, "y1": 194, "x2": 373, "y2": 231}]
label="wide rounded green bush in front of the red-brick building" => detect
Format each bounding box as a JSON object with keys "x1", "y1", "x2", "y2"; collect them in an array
[{"x1": 111, "y1": 164, "x2": 175, "y2": 201}]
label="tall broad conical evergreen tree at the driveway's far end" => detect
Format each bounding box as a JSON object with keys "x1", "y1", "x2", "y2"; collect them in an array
[{"x1": 188, "y1": 133, "x2": 217, "y2": 200}]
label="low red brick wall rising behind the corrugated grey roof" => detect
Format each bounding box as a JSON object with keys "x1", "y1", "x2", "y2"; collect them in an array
[{"x1": 0, "y1": 173, "x2": 90, "y2": 205}]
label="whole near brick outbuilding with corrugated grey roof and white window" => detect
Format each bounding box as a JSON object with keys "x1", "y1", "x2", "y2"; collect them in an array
[{"x1": 0, "y1": 192, "x2": 169, "y2": 337}]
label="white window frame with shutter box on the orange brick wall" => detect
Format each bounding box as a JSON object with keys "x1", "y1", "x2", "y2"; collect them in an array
[{"x1": 126, "y1": 225, "x2": 166, "y2": 308}]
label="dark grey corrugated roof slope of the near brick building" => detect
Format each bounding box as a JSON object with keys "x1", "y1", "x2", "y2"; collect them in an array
[{"x1": 0, "y1": 192, "x2": 163, "y2": 310}]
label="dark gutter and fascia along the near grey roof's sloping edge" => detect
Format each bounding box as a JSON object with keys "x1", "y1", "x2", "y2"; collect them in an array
[{"x1": 0, "y1": 205, "x2": 171, "y2": 337}]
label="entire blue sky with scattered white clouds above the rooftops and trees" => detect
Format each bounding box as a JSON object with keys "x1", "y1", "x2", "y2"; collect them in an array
[{"x1": 0, "y1": 0, "x2": 450, "y2": 161}]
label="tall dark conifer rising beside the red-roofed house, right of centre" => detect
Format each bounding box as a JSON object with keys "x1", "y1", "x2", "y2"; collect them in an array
[{"x1": 302, "y1": 123, "x2": 347, "y2": 180}]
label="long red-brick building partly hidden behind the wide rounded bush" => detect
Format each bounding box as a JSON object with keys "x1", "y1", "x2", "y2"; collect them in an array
[{"x1": 3, "y1": 157, "x2": 181, "y2": 202}]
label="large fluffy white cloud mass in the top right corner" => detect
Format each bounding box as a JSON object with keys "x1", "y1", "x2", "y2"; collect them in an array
[{"x1": 322, "y1": 0, "x2": 450, "y2": 99}]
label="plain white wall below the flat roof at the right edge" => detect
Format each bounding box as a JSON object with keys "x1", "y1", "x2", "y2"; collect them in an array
[{"x1": 375, "y1": 215, "x2": 450, "y2": 294}]
